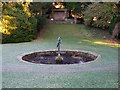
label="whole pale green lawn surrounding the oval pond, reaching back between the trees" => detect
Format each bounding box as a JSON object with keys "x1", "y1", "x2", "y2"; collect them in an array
[{"x1": 0, "y1": 24, "x2": 119, "y2": 88}]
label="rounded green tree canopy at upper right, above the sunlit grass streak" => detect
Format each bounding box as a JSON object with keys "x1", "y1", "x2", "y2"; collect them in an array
[{"x1": 83, "y1": 2, "x2": 115, "y2": 29}]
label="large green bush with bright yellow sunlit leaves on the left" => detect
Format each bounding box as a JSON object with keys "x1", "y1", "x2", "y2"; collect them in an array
[{"x1": 1, "y1": 2, "x2": 37, "y2": 43}]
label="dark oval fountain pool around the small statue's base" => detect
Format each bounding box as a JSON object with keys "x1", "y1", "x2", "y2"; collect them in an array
[{"x1": 18, "y1": 50, "x2": 100, "y2": 64}]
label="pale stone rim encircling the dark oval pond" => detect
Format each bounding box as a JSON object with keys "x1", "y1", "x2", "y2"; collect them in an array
[{"x1": 17, "y1": 49, "x2": 101, "y2": 65}]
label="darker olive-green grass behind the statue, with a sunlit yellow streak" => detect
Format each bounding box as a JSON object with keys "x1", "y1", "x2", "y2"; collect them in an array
[{"x1": 41, "y1": 24, "x2": 120, "y2": 47}]
